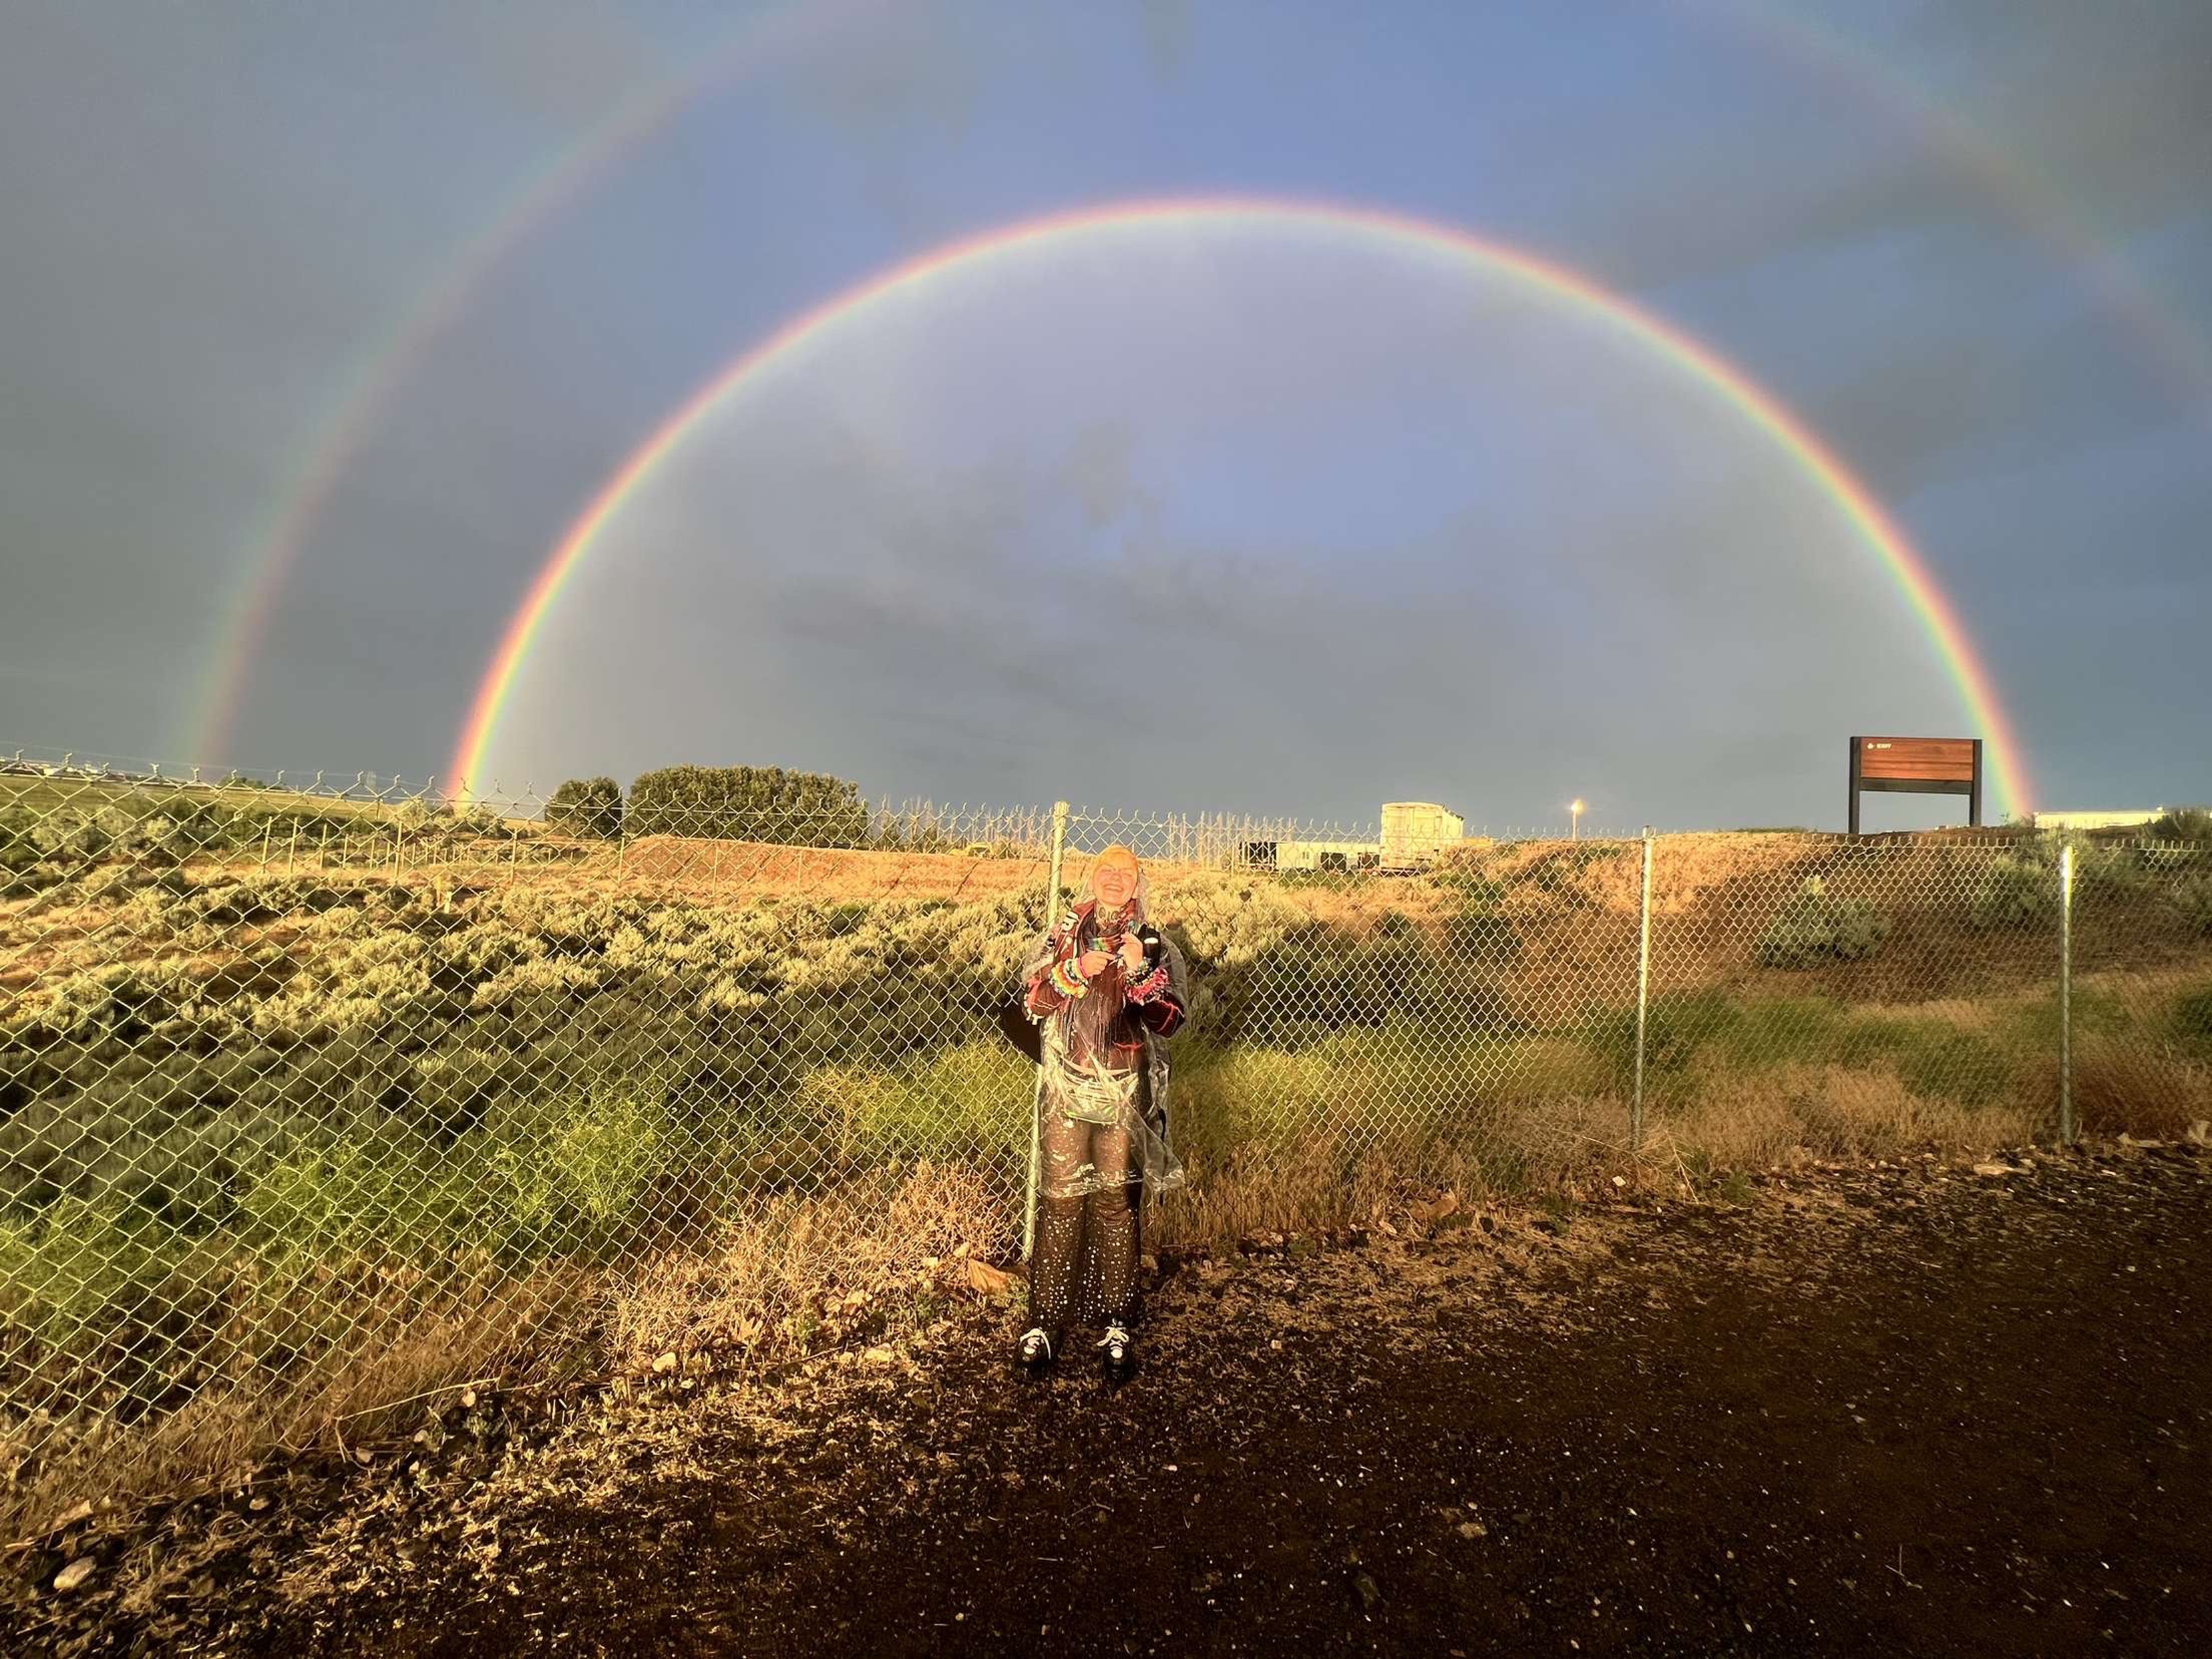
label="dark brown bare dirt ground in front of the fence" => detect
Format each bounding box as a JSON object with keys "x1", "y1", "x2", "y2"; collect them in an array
[{"x1": 17, "y1": 1146, "x2": 2212, "y2": 1659}]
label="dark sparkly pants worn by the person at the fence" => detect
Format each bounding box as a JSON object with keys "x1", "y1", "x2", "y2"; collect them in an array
[{"x1": 1029, "y1": 1101, "x2": 1143, "y2": 1332}]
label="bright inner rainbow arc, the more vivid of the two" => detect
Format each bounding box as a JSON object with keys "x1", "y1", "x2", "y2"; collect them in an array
[{"x1": 449, "y1": 197, "x2": 2030, "y2": 812}]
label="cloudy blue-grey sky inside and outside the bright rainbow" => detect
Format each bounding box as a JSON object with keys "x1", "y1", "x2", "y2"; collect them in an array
[{"x1": 0, "y1": 0, "x2": 2212, "y2": 827}]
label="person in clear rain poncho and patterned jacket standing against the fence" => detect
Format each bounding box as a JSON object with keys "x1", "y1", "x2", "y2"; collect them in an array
[{"x1": 1018, "y1": 845, "x2": 1190, "y2": 1380}]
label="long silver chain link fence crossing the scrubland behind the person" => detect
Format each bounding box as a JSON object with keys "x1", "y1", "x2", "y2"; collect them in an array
[{"x1": 0, "y1": 759, "x2": 2212, "y2": 1530}]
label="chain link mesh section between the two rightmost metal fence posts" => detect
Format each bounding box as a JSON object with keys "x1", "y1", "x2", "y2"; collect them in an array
[{"x1": 1646, "y1": 832, "x2": 2114, "y2": 1163}]
